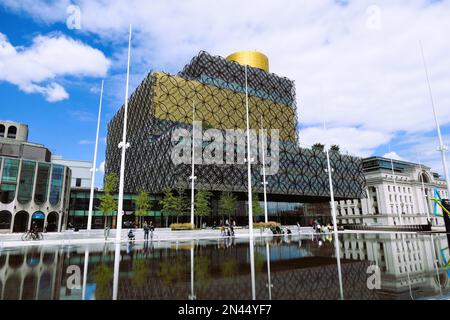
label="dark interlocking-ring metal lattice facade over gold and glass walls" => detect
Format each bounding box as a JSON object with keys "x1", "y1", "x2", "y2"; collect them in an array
[{"x1": 105, "y1": 52, "x2": 365, "y2": 199}]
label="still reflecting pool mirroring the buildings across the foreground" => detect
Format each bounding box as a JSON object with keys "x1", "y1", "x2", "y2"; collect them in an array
[{"x1": 0, "y1": 233, "x2": 450, "y2": 300}]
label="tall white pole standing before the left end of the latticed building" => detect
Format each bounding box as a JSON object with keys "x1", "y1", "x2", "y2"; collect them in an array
[{"x1": 116, "y1": 24, "x2": 131, "y2": 241}]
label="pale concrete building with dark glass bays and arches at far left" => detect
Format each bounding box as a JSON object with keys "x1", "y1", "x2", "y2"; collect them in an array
[{"x1": 0, "y1": 121, "x2": 71, "y2": 232}]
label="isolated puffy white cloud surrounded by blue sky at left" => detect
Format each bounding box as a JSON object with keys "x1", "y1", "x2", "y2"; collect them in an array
[{"x1": 0, "y1": 33, "x2": 110, "y2": 102}]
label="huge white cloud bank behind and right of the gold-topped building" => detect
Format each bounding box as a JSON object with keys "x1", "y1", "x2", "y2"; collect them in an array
[{"x1": 3, "y1": 0, "x2": 450, "y2": 171}]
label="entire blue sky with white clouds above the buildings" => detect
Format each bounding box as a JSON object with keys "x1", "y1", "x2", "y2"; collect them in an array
[{"x1": 0, "y1": 0, "x2": 450, "y2": 185}]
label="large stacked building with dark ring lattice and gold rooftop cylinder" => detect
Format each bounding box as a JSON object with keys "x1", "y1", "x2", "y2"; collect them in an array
[{"x1": 105, "y1": 51, "x2": 365, "y2": 224}]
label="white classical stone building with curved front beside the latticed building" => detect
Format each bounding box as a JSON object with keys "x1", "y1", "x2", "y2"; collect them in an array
[{"x1": 337, "y1": 157, "x2": 449, "y2": 226}]
